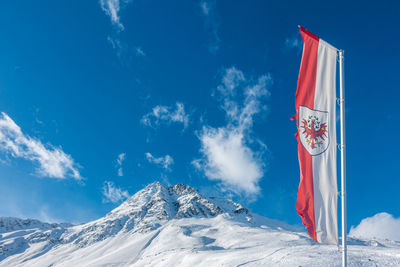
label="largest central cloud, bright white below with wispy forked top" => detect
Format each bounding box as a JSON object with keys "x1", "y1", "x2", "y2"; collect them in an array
[{"x1": 192, "y1": 67, "x2": 272, "y2": 194}]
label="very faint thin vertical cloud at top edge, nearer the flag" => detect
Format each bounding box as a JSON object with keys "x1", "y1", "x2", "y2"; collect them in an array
[{"x1": 200, "y1": 0, "x2": 221, "y2": 54}]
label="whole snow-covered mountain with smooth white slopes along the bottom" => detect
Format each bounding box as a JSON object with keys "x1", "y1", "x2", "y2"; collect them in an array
[{"x1": 0, "y1": 182, "x2": 400, "y2": 266}]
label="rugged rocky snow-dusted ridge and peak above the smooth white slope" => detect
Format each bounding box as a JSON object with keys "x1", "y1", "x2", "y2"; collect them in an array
[{"x1": 0, "y1": 182, "x2": 251, "y2": 260}]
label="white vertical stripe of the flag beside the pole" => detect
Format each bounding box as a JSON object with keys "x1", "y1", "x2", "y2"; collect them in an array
[{"x1": 312, "y1": 39, "x2": 338, "y2": 244}]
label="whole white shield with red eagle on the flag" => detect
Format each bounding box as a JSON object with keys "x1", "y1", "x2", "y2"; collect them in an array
[{"x1": 299, "y1": 106, "x2": 329, "y2": 156}]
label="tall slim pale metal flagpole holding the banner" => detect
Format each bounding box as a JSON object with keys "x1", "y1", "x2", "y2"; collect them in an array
[{"x1": 339, "y1": 50, "x2": 347, "y2": 267}]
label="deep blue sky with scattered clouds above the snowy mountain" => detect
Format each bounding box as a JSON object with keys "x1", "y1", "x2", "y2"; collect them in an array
[{"x1": 0, "y1": 0, "x2": 400, "y2": 233}]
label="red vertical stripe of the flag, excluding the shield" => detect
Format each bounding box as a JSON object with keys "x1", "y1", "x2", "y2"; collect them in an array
[{"x1": 296, "y1": 28, "x2": 319, "y2": 241}]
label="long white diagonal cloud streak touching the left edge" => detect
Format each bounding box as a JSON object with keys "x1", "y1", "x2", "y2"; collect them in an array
[{"x1": 0, "y1": 112, "x2": 82, "y2": 180}]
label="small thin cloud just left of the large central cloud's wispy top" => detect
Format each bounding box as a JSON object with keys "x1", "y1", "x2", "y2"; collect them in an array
[{"x1": 141, "y1": 102, "x2": 189, "y2": 129}]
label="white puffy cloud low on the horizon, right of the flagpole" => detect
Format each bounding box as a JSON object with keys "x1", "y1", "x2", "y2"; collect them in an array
[{"x1": 349, "y1": 212, "x2": 400, "y2": 241}]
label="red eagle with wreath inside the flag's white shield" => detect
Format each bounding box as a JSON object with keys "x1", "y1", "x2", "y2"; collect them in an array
[{"x1": 301, "y1": 116, "x2": 328, "y2": 149}]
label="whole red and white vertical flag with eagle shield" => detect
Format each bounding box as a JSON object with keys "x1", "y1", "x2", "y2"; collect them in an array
[{"x1": 296, "y1": 27, "x2": 338, "y2": 244}]
